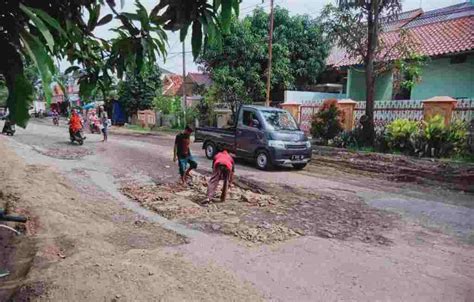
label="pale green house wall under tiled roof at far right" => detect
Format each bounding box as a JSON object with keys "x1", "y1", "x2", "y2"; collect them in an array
[{"x1": 411, "y1": 54, "x2": 474, "y2": 100}]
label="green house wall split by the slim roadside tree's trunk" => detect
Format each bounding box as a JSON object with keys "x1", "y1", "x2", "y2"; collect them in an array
[{"x1": 347, "y1": 68, "x2": 393, "y2": 101}]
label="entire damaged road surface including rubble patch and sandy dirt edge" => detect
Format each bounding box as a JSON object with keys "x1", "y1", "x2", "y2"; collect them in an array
[{"x1": 0, "y1": 122, "x2": 474, "y2": 301}]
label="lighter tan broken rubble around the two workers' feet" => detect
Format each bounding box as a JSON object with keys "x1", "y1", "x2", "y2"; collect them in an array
[{"x1": 121, "y1": 173, "x2": 298, "y2": 243}]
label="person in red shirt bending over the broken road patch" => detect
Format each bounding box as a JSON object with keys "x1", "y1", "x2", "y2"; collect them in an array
[{"x1": 207, "y1": 146, "x2": 235, "y2": 202}]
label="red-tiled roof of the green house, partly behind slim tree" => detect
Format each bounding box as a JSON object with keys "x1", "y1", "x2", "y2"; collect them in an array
[{"x1": 327, "y1": 2, "x2": 474, "y2": 67}]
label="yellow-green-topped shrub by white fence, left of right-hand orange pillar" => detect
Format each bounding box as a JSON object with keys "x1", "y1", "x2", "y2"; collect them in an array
[{"x1": 385, "y1": 119, "x2": 420, "y2": 154}]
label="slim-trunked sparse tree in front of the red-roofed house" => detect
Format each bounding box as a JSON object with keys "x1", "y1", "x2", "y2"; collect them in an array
[{"x1": 321, "y1": 0, "x2": 402, "y2": 144}]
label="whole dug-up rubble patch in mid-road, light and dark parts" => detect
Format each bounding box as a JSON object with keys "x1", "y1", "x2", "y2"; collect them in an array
[{"x1": 122, "y1": 173, "x2": 394, "y2": 245}]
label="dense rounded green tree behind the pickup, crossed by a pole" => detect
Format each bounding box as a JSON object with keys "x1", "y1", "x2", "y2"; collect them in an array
[{"x1": 198, "y1": 7, "x2": 329, "y2": 102}]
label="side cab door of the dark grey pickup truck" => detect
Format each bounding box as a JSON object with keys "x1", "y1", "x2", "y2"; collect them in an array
[{"x1": 235, "y1": 108, "x2": 263, "y2": 158}]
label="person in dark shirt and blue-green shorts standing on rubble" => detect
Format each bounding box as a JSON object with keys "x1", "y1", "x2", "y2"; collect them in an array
[{"x1": 173, "y1": 126, "x2": 197, "y2": 184}]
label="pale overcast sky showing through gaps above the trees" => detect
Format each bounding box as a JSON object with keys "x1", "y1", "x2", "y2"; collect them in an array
[{"x1": 88, "y1": 0, "x2": 465, "y2": 74}]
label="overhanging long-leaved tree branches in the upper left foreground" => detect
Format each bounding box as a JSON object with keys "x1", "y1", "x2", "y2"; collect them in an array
[{"x1": 0, "y1": 0, "x2": 240, "y2": 127}]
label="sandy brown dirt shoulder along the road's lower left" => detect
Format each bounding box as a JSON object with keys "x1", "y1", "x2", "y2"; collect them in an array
[{"x1": 0, "y1": 141, "x2": 260, "y2": 301}]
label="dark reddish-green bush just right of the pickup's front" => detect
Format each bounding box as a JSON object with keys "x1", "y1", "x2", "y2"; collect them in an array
[{"x1": 311, "y1": 100, "x2": 342, "y2": 143}]
